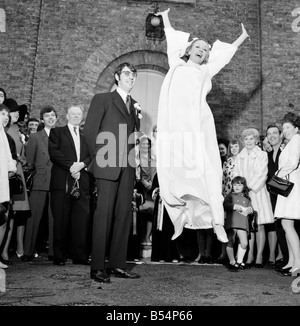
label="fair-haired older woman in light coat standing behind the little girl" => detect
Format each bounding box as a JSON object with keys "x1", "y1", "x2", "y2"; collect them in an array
[{"x1": 234, "y1": 128, "x2": 274, "y2": 268}]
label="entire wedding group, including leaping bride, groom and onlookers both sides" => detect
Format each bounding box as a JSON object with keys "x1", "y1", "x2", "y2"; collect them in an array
[{"x1": 0, "y1": 10, "x2": 300, "y2": 283}]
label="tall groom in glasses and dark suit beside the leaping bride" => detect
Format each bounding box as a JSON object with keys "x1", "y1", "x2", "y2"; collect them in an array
[{"x1": 84, "y1": 63, "x2": 140, "y2": 283}]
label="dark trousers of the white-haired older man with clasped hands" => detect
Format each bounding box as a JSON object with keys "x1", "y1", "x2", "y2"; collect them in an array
[{"x1": 51, "y1": 190, "x2": 90, "y2": 260}]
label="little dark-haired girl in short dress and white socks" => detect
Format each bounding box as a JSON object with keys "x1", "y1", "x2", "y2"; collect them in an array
[{"x1": 223, "y1": 176, "x2": 253, "y2": 269}]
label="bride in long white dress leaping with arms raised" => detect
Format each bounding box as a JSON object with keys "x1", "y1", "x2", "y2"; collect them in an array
[{"x1": 157, "y1": 9, "x2": 249, "y2": 242}]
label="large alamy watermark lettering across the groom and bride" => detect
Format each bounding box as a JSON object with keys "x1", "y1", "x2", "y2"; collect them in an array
[{"x1": 96, "y1": 124, "x2": 206, "y2": 173}]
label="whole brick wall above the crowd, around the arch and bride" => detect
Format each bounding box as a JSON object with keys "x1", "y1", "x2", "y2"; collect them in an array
[{"x1": 0, "y1": 0, "x2": 300, "y2": 137}]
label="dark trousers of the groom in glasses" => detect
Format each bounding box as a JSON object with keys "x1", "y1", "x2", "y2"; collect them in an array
[{"x1": 91, "y1": 167, "x2": 135, "y2": 270}]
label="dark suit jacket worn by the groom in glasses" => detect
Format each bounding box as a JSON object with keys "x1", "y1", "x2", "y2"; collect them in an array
[{"x1": 84, "y1": 91, "x2": 140, "y2": 180}]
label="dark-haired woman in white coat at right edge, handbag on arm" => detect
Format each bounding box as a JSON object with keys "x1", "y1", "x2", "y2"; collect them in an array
[{"x1": 275, "y1": 112, "x2": 300, "y2": 275}]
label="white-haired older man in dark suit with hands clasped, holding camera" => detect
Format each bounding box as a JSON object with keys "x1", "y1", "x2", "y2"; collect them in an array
[{"x1": 49, "y1": 106, "x2": 90, "y2": 266}]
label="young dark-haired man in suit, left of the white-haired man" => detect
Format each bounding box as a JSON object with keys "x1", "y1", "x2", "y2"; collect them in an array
[{"x1": 21, "y1": 105, "x2": 57, "y2": 261}]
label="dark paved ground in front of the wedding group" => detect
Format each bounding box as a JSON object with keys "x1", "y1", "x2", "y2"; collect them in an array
[{"x1": 0, "y1": 257, "x2": 300, "y2": 308}]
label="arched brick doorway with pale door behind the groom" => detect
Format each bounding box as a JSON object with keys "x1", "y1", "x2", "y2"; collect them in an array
[{"x1": 74, "y1": 50, "x2": 169, "y2": 135}]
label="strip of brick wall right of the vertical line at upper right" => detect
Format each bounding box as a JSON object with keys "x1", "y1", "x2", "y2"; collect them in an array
[{"x1": 261, "y1": 0, "x2": 300, "y2": 134}]
